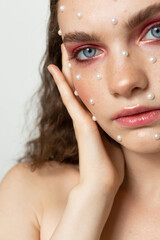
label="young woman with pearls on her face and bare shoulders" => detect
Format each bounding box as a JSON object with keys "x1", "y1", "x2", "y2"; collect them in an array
[{"x1": 0, "y1": 0, "x2": 160, "y2": 240}]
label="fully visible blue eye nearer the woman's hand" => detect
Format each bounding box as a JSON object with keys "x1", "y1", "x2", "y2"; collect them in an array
[{"x1": 77, "y1": 47, "x2": 102, "y2": 60}]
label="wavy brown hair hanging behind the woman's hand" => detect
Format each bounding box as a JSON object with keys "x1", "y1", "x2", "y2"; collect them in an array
[{"x1": 18, "y1": 0, "x2": 117, "y2": 171}]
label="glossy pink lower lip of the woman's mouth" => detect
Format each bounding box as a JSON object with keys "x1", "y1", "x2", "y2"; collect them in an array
[{"x1": 116, "y1": 110, "x2": 160, "y2": 127}]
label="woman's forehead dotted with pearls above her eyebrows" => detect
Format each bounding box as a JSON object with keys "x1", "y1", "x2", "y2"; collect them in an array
[{"x1": 58, "y1": 0, "x2": 160, "y2": 32}]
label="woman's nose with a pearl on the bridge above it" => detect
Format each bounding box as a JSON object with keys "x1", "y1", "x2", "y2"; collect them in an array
[{"x1": 108, "y1": 63, "x2": 148, "y2": 98}]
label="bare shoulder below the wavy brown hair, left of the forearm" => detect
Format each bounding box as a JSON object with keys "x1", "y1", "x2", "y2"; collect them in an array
[{"x1": 0, "y1": 162, "x2": 79, "y2": 240}]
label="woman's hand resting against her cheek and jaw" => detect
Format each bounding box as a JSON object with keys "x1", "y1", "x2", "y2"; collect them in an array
[{"x1": 48, "y1": 45, "x2": 124, "y2": 198}]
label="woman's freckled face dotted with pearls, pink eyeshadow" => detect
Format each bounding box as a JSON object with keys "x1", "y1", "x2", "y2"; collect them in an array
[{"x1": 58, "y1": 0, "x2": 160, "y2": 152}]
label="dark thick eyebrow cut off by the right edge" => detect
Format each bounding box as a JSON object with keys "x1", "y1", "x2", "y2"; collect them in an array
[{"x1": 125, "y1": 4, "x2": 160, "y2": 31}]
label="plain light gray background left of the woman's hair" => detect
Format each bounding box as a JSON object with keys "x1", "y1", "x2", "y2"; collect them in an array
[{"x1": 0, "y1": 0, "x2": 49, "y2": 181}]
